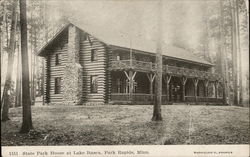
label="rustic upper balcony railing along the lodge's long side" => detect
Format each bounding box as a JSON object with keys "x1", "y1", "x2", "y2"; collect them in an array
[{"x1": 110, "y1": 60, "x2": 222, "y2": 81}]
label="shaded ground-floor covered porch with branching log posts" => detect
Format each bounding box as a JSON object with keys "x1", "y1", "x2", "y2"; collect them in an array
[{"x1": 110, "y1": 69, "x2": 223, "y2": 104}]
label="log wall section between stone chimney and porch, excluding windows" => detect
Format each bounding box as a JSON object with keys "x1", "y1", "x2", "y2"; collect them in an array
[{"x1": 79, "y1": 32, "x2": 108, "y2": 104}]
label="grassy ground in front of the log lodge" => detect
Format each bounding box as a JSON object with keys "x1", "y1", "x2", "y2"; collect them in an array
[{"x1": 1, "y1": 105, "x2": 249, "y2": 146}]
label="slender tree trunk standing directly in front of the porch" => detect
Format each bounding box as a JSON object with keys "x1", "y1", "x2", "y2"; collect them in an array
[{"x1": 152, "y1": 0, "x2": 163, "y2": 121}]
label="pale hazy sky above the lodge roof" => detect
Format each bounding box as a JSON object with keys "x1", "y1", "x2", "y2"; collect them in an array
[{"x1": 55, "y1": 0, "x2": 207, "y2": 45}]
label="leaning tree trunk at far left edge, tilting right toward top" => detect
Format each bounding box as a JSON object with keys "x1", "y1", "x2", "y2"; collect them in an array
[{"x1": 2, "y1": 0, "x2": 17, "y2": 121}]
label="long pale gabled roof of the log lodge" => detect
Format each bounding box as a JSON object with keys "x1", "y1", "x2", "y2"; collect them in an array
[{"x1": 38, "y1": 22, "x2": 213, "y2": 66}]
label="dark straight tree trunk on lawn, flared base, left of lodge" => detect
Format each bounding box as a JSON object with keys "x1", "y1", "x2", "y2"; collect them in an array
[{"x1": 19, "y1": 0, "x2": 33, "y2": 133}]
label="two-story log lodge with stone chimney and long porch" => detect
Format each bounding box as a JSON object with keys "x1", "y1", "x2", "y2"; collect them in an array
[{"x1": 37, "y1": 23, "x2": 223, "y2": 105}]
